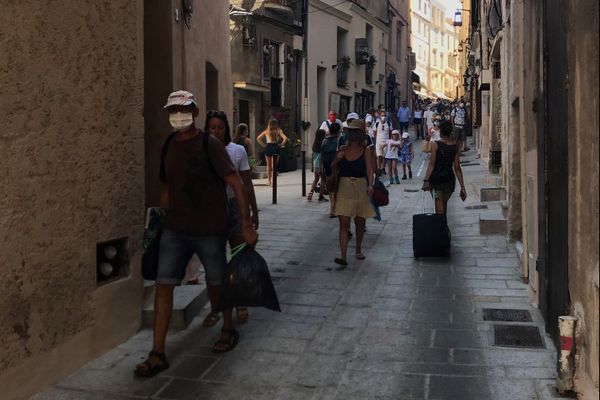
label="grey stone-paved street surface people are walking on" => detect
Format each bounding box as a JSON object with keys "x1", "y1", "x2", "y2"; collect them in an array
[{"x1": 35, "y1": 140, "x2": 555, "y2": 400}]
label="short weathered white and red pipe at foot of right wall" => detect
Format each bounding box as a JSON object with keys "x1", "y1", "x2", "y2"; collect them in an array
[{"x1": 556, "y1": 316, "x2": 577, "y2": 394}]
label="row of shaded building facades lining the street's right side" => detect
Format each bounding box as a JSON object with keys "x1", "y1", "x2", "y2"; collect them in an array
[{"x1": 465, "y1": 0, "x2": 599, "y2": 399}]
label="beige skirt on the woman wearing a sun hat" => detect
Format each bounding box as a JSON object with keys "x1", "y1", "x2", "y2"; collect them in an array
[{"x1": 335, "y1": 177, "x2": 375, "y2": 218}]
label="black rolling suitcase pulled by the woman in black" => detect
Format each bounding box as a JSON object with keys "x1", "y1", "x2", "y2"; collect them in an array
[{"x1": 413, "y1": 192, "x2": 450, "y2": 258}]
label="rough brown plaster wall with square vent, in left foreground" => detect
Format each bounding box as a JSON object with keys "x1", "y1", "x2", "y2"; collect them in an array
[{"x1": 0, "y1": 0, "x2": 144, "y2": 399}]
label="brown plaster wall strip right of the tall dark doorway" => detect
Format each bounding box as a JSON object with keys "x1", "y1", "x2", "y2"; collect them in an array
[{"x1": 566, "y1": 0, "x2": 599, "y2": 399}]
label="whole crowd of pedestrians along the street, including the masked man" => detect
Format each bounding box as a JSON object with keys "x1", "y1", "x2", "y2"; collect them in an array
[{"x1": 135, "y1": 91, "x2": 468, "y2": 377}]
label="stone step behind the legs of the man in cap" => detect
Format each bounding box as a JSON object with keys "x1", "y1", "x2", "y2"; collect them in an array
[{"x1": 143, "y1": 280, "x2": 208, "y2": 330}]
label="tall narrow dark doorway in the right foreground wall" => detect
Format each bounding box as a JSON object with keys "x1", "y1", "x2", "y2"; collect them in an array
[{"x1": 538, "y1": 0, "x2": 570, "y2": 348}]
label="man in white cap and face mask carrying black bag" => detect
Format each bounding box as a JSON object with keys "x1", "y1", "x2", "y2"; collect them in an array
[{"x1": 135, "y1": 90, "x2": 257, "y2": 377}]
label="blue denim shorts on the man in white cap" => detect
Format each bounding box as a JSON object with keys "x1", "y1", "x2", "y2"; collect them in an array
[{"x1": 156, "y1": 229, "x2": 227, "y2": 286}]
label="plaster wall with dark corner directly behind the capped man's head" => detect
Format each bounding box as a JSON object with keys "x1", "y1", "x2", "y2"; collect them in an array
[{"x1": 144, "y1": 0, "x2": 233, "y2": 206}]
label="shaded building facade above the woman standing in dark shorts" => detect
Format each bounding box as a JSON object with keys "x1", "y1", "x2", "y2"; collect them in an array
[{"x1": 230, "y1": 0, "x2": 304, "y2": 168}]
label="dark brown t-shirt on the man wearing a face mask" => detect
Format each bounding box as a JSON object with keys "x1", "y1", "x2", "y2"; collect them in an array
[{"x1": 160, "y1": 131, "x2": 235, "y2": 236}]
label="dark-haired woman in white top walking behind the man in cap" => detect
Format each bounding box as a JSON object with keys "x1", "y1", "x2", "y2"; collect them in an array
[{"x1": 204, "y1": 111, "x2": 258, "y2": 325}]
